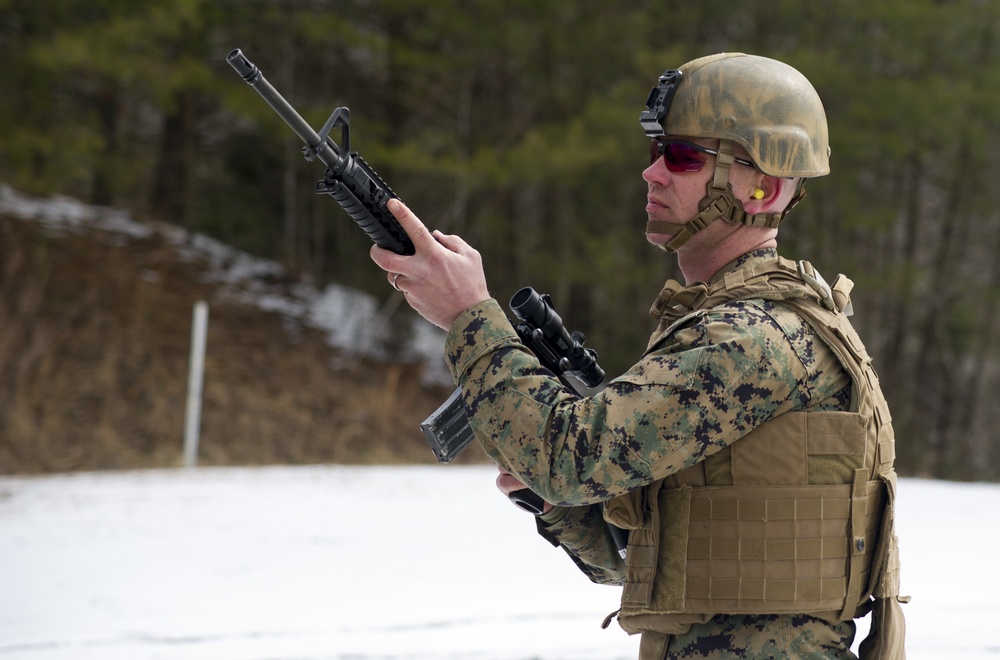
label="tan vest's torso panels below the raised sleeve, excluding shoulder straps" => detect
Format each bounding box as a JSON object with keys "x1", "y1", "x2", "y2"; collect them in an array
[{"x1": 622, "y1": 422, "x2": 885, "y2": 621}]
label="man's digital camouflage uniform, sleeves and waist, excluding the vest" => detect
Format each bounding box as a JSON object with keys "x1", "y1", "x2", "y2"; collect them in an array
[{"x1": 446, "y1": 250, "x2": 854, "y2": 658}]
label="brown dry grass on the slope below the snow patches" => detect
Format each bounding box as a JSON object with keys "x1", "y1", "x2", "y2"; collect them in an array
[{"x1": 0, "y1": 214, "x2": 483, "y2": 474}]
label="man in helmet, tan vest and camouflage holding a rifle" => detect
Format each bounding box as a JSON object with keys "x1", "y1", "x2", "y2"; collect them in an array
[{"x1": 372, "y1": 53, "x2": 905, "y2": 660}]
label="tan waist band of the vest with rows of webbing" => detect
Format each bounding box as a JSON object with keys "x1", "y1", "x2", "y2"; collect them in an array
[{"x1": 676, "y1": 472, "x2": 884, "y2": 620}]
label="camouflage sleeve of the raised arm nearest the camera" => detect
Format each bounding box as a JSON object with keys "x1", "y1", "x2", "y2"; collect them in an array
[{"x1": 446, "y1": 300, "x2": 836, "y2": 507}]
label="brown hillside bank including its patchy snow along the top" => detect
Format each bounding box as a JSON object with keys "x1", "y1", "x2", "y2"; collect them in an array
[{"x1": 0, "y1": 188, "x2": 482, "y2": 474}]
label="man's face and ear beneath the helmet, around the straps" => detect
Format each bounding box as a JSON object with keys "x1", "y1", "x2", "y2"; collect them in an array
[{"x1": 642, "y1": 136, "x2": 756, "y2": 245}]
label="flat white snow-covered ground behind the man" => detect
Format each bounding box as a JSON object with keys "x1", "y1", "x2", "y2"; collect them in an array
[{"x1": 0, "y1": 466, "x2": 1000, "y2": 660}]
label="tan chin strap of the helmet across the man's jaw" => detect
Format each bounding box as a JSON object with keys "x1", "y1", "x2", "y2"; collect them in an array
[{"x1": 646, "y1": 140, "x2": 788, "y2": 252}]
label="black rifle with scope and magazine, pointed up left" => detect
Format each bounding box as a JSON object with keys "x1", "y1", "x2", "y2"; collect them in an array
[{"x1": 226, "y1": 48, "x2": 616, "y2": 536}]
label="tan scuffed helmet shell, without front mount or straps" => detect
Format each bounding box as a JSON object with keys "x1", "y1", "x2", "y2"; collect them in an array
[{"x1": 663, "y1": 53, "x2": 830, "y2": 177}]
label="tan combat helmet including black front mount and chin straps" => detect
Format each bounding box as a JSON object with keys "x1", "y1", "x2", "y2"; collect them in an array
[{"x1": 639, "y1": 53, "x2": 830, "y2": 251}]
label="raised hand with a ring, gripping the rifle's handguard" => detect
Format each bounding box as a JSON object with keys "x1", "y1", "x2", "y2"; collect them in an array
[{"x1": 371, "y1": 199, "x2": 490, "y2": 330}]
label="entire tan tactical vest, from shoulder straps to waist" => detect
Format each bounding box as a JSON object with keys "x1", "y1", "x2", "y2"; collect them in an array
[{"x1": 609, "y1": 259, "x2": 898, "y2": 633}]
